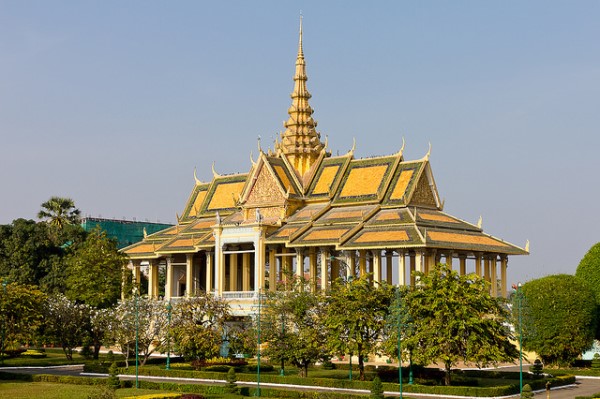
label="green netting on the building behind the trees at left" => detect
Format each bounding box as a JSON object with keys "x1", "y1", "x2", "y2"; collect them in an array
[{"x1": 81, "y1": 218, "x2": 172, "y2": 248}]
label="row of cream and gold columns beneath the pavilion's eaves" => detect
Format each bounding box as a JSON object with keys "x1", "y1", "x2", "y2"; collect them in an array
[{"x1": 130, "y1": 246, "x2": 508, "y2": 299}]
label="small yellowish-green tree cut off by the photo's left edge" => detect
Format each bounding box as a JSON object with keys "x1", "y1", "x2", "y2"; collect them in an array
[{"x1": 0, "y1": 283, "x2": 46, "y2": 351}]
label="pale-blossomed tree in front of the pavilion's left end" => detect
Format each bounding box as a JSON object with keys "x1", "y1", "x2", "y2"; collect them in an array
[{"x1": 105, "y1": 296, "x2": 168, "y2": 367}]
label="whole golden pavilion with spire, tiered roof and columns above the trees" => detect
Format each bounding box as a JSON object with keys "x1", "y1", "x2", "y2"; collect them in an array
[{"x1": 123, "y1": 20, "x2": 528, "y2": 316}]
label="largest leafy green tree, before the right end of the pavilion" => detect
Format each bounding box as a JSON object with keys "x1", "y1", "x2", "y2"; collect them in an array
[{"x1": 393, "y1": 264, "x2": 518, "y2": 385}]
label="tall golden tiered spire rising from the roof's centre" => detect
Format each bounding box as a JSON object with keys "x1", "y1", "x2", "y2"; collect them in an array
[{"x1": 277, "y1": 15, "x2": 324, "y2": 177}]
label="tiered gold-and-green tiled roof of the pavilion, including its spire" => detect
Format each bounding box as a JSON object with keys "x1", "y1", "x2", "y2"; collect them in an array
[{"x1": 123, "y1": 18, "x2": 528, "y2": 259}]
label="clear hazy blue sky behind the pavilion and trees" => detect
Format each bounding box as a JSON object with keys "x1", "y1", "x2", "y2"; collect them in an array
[{"x1": 0, "y1": 0, "x2": 600, "y2": 284}]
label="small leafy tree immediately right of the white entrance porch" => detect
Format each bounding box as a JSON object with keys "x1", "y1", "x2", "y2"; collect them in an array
[{"x1": 261, "y1": 277, "x2": 327, "y2": 377}]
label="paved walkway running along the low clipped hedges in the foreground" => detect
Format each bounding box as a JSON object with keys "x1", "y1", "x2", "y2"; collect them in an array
[{"x1": 0, "y1": 365, "x2": 600, "y2": 399}]
